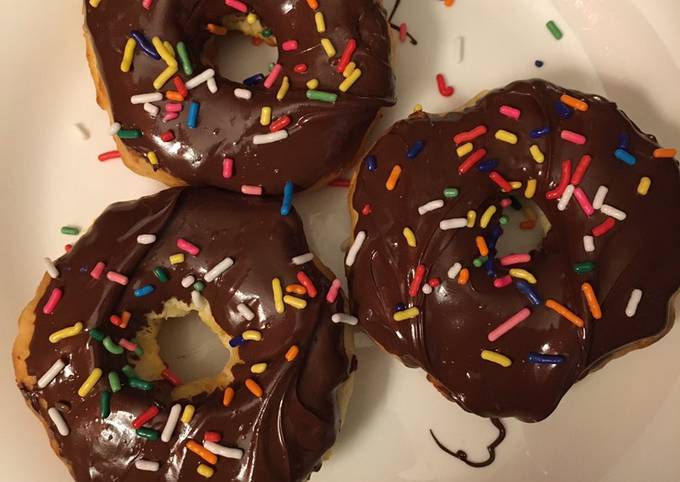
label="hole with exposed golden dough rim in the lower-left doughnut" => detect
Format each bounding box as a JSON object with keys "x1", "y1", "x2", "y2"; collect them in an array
[{"x1": 134, "y1": 298, "x2": 240, "y2": 400}]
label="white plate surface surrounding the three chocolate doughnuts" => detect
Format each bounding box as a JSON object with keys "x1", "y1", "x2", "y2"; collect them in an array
[{"x1": 0, "y1": 0, "x2": 680, "y2": 482}]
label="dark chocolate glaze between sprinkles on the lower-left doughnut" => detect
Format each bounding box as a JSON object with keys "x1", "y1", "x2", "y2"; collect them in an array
[{"x1": 20, "y1": 188, "x2": 353, "y2": 482}]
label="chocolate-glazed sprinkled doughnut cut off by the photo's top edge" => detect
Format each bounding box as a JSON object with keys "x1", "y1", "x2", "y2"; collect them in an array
[{"x1": 84, "y1": 0, "x2": 394, "y2": 194}]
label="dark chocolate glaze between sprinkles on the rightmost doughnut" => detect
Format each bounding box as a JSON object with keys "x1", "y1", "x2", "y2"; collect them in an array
[{"x1": 347, "y1": 80, "x2": 680, "y2": 421}]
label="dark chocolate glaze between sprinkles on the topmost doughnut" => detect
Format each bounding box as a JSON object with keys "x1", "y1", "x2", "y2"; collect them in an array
[{"x1": 84, "y1": 0, "x2": 394, "y2": 194}]
